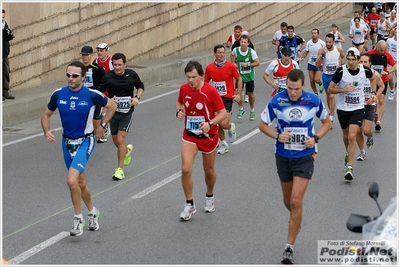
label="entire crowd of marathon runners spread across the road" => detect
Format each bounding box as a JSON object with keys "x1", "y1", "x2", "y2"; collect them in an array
[{"x1": 36, "y1": 7, "x2": 396, "y2": 263}]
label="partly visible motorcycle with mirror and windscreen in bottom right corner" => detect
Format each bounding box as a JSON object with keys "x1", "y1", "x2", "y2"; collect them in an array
[{"x1": 341, "y1": 182, "x2": 398, "y2": 265}]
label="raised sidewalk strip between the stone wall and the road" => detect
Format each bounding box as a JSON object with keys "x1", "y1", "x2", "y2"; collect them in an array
[{"x1": 2, "y1": 13, "x2": 352, "y2": 127}]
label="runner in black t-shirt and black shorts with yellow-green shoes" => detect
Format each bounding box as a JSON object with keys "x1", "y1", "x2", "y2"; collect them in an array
[{"x1": 98, "y1": 53, "x2": 144, "y2": 180}]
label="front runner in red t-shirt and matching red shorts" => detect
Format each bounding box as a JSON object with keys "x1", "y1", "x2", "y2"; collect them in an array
[{"x1": 176, "y1": 61, "x2": 227, "y2": 221}]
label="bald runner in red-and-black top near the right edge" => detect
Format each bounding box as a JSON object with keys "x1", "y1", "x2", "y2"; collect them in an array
[{"x1": 367, "y1": 40, "x2": 396, "y2": 132}]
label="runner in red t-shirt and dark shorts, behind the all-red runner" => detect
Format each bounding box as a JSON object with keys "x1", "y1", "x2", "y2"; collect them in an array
[{"x1": 204, "y1": 45, "x2": 242, "y2": 154}]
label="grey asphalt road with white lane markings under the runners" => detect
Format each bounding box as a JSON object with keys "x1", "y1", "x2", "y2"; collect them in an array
[{"x1": 2, "y1": 37, "x2": 397, "y2": 265}]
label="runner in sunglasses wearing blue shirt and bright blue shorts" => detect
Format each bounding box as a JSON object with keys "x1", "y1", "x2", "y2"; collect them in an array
[{"x1": 41, "y1": 61, "x2": 116, "y2": 236}]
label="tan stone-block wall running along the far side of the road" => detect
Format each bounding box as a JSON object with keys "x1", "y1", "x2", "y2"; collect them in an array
[{"x1": 2, "y1": 2, "x2": 354, "y2": 91}]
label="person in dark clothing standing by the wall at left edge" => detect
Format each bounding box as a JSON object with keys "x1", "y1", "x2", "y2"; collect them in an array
[{"x1": 2, "y1": 9, "x2": 15, "y2": 101}]
